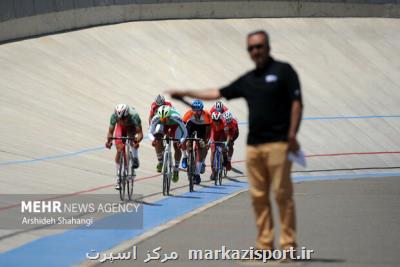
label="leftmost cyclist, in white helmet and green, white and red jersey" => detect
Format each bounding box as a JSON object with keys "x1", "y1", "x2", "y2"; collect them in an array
[{"x1": 106, "y1": 104, "x2": 143, "y2": 190}]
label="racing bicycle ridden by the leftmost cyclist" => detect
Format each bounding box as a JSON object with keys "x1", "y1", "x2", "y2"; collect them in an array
[{"x1": 111, "y1": 137, "x2": 136, "y2": 201}]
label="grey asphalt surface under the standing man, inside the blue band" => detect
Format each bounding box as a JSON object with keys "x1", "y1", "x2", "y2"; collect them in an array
[{"x1": 101, "y1": 177, "x2": 400, "y2": 267}]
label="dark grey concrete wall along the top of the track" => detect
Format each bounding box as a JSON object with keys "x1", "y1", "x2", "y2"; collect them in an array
[{"x1": 0, "y1": 0, "x2": 400, "y2": 42}]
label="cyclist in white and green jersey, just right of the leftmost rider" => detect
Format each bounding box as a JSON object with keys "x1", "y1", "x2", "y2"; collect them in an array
[{"x1": 149, "y1": 105, "x2": 187, "y2": 183}]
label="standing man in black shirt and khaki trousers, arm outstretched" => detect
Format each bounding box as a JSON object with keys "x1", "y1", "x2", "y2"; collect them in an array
[{"x1": 169, "y1": 31, "x2": 302, "y2": 254}]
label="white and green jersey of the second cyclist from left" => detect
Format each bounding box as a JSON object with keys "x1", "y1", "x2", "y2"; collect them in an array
[{"x1": 148, "y1": 108, "x2": 187, "y2": 141}]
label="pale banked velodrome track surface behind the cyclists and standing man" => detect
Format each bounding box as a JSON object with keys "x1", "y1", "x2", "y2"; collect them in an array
[{"x1": 0, "y1": 18, "x2": 400, "y2": 263}]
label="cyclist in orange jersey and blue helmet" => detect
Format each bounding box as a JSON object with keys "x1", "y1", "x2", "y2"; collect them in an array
[{"x1": 182, "y1": 99, "x2": 212, "y2": 184}]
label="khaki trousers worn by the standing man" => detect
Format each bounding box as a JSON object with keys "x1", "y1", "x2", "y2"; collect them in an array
[{"x1": 247, "y1": 142, "x2": 297, "y2": 249}]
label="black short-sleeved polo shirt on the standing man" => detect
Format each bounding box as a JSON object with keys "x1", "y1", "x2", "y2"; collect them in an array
[{"x1": 220, "y1": 57, "x2": 301, "y2": 145}]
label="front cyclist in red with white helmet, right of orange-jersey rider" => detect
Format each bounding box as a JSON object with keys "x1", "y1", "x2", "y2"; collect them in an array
[{"x1": 210, "y1": 111, "x2": 227, "y2": 180}]
